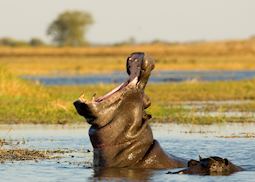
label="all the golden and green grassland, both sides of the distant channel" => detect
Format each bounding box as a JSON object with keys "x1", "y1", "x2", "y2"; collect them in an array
[{"x1": 0, "y1": 40, "x2": 255, "y2": 124}]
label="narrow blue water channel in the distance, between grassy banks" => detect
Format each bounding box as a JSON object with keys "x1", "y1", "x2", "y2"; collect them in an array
[{"x1": 23, "y1": 71, "x2": 255, "y2": 85}]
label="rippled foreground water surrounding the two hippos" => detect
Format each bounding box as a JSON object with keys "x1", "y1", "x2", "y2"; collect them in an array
[{"x1": 0, "y1": 124, "x2": 255, "y2": 182}]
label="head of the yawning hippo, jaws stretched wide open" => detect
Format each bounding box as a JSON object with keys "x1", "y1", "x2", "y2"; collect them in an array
[{"x1": 74, "y1": 52, "x2": 154, "y2": 126}]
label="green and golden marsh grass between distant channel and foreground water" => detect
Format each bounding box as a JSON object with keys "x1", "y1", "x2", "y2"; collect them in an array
[{"x1": 0, "y1": 67, "x2": 255, "y2": 124}]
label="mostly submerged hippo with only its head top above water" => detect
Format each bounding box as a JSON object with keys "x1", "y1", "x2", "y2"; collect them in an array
[{"x1": 168, "y1": 156, "x2": 243, "y2": 175}]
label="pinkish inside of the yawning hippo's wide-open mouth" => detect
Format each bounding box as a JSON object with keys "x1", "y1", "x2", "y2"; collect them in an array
[{"x1": 94, "y1": 52, "x2": 144, "y2": 102}]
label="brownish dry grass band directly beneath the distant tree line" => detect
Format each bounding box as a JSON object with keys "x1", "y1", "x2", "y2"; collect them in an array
[{"x1": 0, "y1": 39, "x2": 255, "y2": 56}]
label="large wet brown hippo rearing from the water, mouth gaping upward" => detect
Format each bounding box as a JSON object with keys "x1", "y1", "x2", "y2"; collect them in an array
[{"x1": 74, "y1": 52, "x2": 187, "y2": 169}]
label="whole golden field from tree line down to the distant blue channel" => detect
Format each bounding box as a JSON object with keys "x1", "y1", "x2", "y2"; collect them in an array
[{"x1": 0, "y1": 40, "x2": 255, "y2": 75}]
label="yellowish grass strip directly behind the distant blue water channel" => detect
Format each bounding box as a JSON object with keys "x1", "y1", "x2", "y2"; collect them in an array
[{"x1": 0, "y1": 54, "x2": 255, "y2": 76}]
